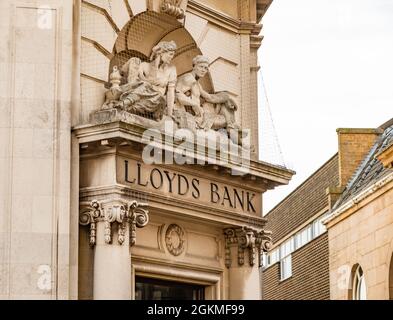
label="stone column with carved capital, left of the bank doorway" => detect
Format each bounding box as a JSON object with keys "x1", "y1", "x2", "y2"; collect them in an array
[{"x1": 80, "y1": 200, "x2": 149, "y2": 300}]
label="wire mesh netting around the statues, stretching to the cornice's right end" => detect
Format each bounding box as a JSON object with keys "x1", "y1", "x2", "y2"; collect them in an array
[{"x1": 80, "y1": 0, "x2": 285, "y2": 162}]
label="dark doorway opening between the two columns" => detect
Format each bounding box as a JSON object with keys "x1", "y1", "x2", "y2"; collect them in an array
[{"x1": 135, "y1": 277, "x2": 205, "y2": 300}]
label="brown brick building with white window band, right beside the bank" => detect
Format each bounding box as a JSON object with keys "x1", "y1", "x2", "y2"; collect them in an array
[{"x1": 262, "y1": 154, "x2": 339, "y2": 300}]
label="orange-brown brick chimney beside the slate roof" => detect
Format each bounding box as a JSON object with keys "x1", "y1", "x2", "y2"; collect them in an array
[{"x1": 337, "y1": 128, "x2": 383, "y2": 189}]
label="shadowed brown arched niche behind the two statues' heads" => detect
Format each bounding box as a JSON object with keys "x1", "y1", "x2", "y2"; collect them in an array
[{"x1": 108, "y1": 11, "x2": 214, "y2": 92}]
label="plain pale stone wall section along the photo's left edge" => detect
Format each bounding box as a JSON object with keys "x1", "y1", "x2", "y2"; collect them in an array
[{"x1": 0, "y1": 0, "x2": 73, "y2": 299}]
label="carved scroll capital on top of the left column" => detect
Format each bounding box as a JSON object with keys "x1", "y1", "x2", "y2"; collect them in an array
[{"x1": 79, "y1": 200, "x2": 149, "y2": 246}]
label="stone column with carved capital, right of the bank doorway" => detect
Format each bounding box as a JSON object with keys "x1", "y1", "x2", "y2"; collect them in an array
[{"x1": 224, "y1": 227, "x2": 271, "y2": 300}]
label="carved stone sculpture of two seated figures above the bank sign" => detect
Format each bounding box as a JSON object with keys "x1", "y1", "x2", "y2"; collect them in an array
[{"x1": 103, "y1": 41, "x2": 248, "y2": 144}]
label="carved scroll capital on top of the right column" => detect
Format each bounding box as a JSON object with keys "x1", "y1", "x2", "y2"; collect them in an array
[{"x1": 224, "y1": 227, "x2": 272, "y2": 268}]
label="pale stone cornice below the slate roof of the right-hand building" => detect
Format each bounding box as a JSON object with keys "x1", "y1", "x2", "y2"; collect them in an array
[{"x1": 323, "y1": 172, "x2": 393, "y2": 228}]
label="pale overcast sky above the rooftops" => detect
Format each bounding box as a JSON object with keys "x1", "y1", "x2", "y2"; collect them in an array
[{"x1": 259, "y1": 0, "x2": 393, "y2": 213}]
